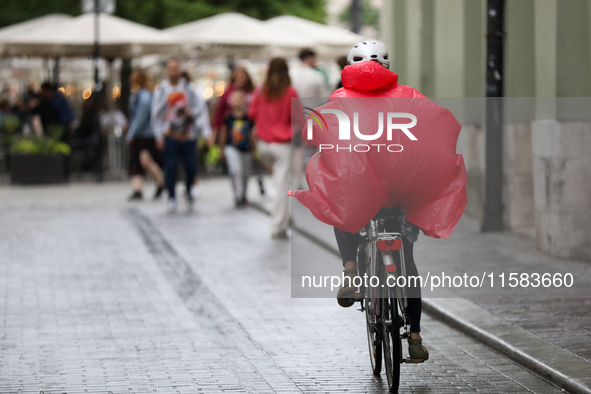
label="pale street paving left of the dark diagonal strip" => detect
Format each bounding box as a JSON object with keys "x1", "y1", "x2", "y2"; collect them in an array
[{"x1": 0, "y1": 184, "x2": 243, "y2": 394}]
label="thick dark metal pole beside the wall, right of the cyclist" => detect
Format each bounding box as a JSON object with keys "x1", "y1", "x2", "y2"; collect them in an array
[{"x1": 482, "y1": 0, "x2": 505, "y2": 232}]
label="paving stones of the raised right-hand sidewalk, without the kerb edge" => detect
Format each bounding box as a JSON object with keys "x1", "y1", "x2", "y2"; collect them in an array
[{"x1": 292, "y1": 189, "x2": 591, "y2": 361}]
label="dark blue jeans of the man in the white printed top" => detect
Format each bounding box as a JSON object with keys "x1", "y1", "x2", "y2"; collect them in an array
[{"x1": 164, "y1": 137, "x2": 197, "y2": 198}]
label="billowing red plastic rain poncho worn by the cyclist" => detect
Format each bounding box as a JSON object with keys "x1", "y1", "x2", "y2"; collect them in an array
[{"x1": 290, "y1": 61, "x2": 466, "y2": 238}]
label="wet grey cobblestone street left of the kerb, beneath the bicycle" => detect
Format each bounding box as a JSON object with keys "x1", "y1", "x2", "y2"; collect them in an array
[{"x1": 0, "y1": 180, "x2": 560, "y2": 394}]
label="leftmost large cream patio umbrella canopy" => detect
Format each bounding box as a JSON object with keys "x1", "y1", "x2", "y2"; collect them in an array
[{"x1": 0, "y1": 13, "x2": 182, "y2": 58}]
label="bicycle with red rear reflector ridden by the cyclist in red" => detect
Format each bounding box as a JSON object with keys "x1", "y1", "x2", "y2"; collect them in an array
[{"x1": 346, "y1": 207, "x2": 410, "y2": 393}]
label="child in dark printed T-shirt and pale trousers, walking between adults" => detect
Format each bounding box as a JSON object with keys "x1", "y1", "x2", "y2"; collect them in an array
[{"x1": 220, "y1": 90, "x2": 255, "y2": 207}]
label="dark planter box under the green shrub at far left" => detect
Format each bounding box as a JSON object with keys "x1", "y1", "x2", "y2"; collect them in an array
[{"x1": 10, "y1": 155, "x2": 66, "y2": 185}]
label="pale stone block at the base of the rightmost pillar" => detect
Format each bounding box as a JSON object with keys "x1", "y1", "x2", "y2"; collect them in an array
[{"x1": 532, "y1": 120, "x2": 591, "y2": 257}]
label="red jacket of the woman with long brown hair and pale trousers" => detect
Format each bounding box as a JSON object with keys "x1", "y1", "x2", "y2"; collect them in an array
[{"x1": 248, "y1": 86, "x2": 303, "y2": 143}]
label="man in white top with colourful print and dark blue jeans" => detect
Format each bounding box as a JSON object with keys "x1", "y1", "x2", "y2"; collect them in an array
[{"x1": 152, "y1": 58, "x2": 201, "y2": 212}]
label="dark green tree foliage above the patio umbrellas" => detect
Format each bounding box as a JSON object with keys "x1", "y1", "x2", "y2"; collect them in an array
[{"x1": 0, "y1": 0, "x2": 326, "y2": 29}]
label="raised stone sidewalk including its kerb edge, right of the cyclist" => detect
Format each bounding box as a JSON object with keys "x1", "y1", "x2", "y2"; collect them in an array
[{"x1": 262, "y1": 186, "x2": 591, "y2": 393}]
